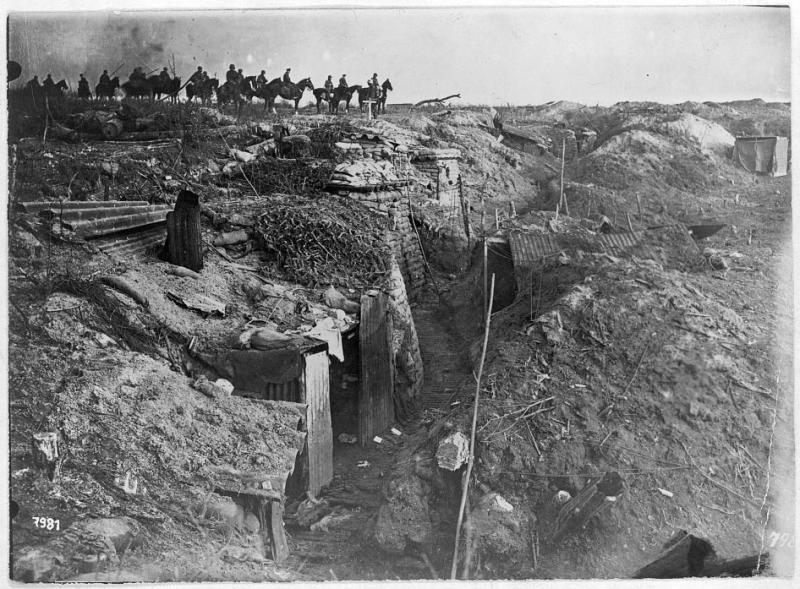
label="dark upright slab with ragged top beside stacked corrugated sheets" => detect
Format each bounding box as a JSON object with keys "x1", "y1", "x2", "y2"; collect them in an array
[{"x1": 164, "y1": 190, "x2": 203, "y2": 272}]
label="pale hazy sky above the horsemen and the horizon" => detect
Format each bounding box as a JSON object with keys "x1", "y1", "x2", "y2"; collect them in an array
[{"x1": 8, "y1": 5, "x2": 791, "y2": 105}]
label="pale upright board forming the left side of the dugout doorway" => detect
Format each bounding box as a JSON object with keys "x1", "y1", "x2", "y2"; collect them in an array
[{"x1": 300, "y1": 352, "x2": 333, "y2": 496}]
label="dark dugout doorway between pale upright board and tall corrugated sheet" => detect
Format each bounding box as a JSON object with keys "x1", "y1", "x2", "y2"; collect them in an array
[{"x1": 330, "y1": 326, "x2": 361, "y2": 440}]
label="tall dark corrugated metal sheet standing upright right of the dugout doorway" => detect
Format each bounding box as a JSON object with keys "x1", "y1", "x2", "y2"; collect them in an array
[{"x1": 358, "y1": 293, "x2": 394, "y2": 446}]
